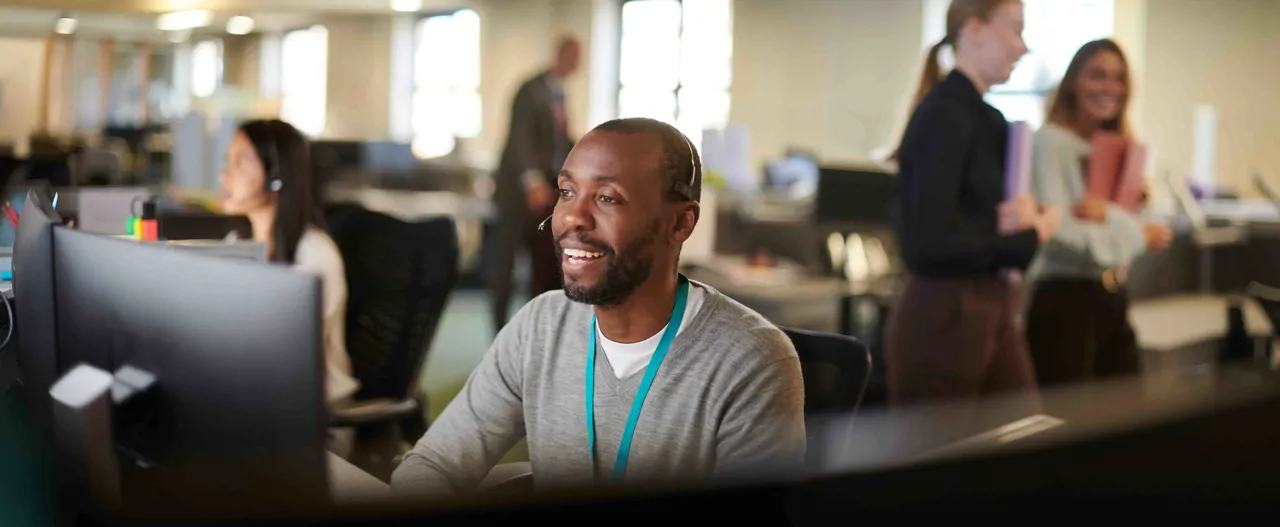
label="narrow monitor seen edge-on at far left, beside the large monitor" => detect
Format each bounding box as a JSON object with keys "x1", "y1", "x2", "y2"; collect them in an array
[{"x1": 13, "y1": 189, "x2": 61, "y2": 426}]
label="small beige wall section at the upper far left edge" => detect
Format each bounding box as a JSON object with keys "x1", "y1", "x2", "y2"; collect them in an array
[{"x1": 0, "y1": 38, "x2": 45, "y2": 142}]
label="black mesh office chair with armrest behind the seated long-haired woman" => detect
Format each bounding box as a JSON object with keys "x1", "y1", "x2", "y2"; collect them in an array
[{"x1": 325, "y1": 205, "x2": 458, "y2": 481}]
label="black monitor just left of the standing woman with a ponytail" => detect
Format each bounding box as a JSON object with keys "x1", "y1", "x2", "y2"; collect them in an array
[{"x1": 814, "y1": 166, "x2": 897, "y2": 226}]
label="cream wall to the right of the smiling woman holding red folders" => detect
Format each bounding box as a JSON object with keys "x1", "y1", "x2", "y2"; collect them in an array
[{"x1": 1140, "y1": 0, "x2": 1280, "y2": 193}]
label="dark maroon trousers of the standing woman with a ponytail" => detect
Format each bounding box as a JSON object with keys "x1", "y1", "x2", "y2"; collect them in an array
[{"x1": 884, "y1": 276, "x2": 1039, "y2": 416}]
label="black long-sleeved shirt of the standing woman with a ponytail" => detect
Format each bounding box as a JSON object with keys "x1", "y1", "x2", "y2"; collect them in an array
[{"x1": 897, "y1": 72, "x2": 1039, "y2": 278}]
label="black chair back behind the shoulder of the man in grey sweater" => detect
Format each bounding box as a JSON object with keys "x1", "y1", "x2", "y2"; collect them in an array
[{"x1": 782, "y1": 327, "x2": 872, "y2": 463}]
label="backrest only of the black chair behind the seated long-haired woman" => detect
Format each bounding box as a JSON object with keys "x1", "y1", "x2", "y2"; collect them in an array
[{"x1": 326, "y1": 205, "x2": 458, "y2": 435}]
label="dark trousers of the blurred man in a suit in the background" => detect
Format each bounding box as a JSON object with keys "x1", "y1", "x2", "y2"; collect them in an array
[{"x1": 489, "y1": 207, "x2": 562, "y2": 334}]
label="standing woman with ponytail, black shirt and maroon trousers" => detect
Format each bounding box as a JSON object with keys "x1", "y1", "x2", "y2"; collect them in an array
[{"x1": 884, "y1": 0, "x2": 1059, "y2": 412}]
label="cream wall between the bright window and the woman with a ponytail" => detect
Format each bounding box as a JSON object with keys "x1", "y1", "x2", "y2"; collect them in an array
[{"x1": 730, "y1": 0, "x2": 923, "y2": 176}]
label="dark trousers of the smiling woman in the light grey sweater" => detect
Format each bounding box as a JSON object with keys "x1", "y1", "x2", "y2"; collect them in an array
[{"x1": 1027, "y1": 279, "x2": 1139, "y2": 386}]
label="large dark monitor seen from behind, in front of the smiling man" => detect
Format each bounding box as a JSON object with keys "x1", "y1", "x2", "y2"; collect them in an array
[{"x1": 52, "y1": 226, "x2": 329, "y2": 517}]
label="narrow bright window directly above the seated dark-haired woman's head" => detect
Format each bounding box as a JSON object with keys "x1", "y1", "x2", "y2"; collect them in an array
[{"x1": 280, "y1": 26, "x2": 329, "y2": 137}]
